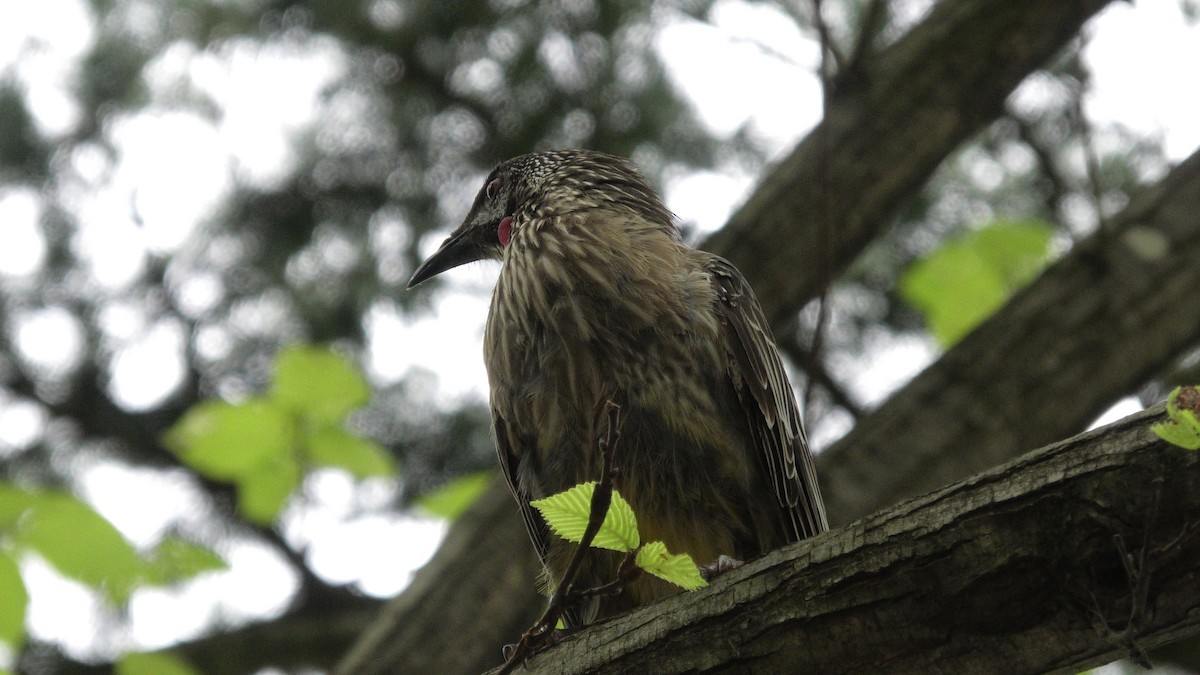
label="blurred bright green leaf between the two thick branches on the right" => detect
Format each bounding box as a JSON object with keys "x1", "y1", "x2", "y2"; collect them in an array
[{"x1": 900, "y1": 220, "x2": 1054, "y2": 347}]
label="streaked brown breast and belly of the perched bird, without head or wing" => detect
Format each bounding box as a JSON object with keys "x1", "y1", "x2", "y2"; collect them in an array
[{"x1": 485, "y1": 208, "x2": 803, "y2": 615}]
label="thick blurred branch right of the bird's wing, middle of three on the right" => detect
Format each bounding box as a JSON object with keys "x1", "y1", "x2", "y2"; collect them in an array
[{"x1": 817, "y1": 147, "x2": 1200, "y2": 525}]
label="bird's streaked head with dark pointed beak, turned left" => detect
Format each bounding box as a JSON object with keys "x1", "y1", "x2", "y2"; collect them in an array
[{"x1": 408, "y1": 150, "x2": 674, "y2": 288}]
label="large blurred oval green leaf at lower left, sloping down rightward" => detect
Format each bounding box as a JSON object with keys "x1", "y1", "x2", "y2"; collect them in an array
[{"x1": 16, "y1": 492, "x2": 142, "y2": 604}]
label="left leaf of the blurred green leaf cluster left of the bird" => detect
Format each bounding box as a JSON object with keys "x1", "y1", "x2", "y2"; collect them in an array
[{"x1": 163, "y1": 399, "x2": 295, "y2": 480}]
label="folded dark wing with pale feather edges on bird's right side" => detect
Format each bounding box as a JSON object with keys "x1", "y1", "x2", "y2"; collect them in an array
[{"x1": 706, "y1": 256, "x2": 829, "y2": 539}]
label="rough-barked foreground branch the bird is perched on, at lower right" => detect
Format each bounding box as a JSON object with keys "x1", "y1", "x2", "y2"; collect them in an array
[{"x1": 494, "y1": 406, "x2": 1200, "y2": 674}]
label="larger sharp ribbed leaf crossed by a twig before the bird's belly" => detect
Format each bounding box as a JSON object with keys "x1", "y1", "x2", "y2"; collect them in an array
[{"x1": 529, "y1": 480, "x2": 640, "y2": 552}]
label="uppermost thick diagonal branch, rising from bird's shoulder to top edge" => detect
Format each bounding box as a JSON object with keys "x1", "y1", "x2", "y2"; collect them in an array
[{"x1": 701, "y1": 0, "x2": 1109, "y2": 330}]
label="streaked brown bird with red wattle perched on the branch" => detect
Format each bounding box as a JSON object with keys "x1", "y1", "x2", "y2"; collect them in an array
[{"x1": 408, "y1": 149, "x2": 828, "y2": 626}]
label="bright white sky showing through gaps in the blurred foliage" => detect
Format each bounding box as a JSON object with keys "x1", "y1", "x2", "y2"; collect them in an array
[{"x1": 0, "y1": 0, "x2": 1200, "y2": 665}]
